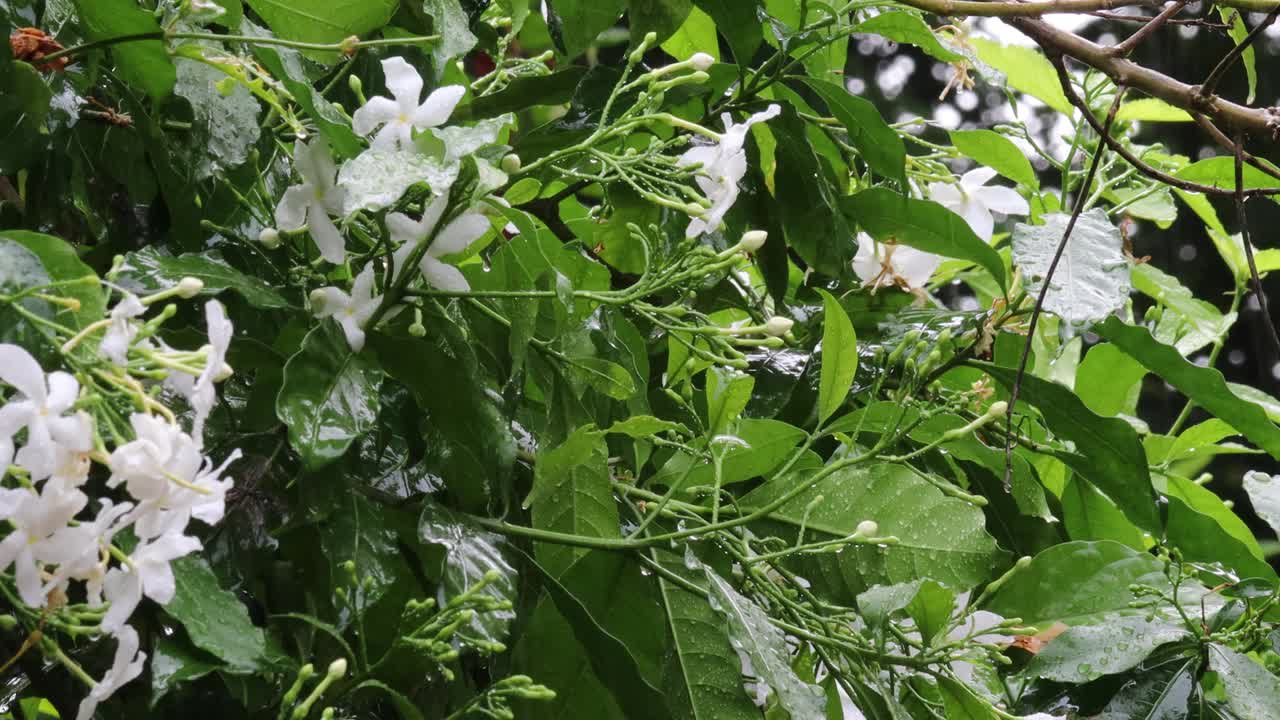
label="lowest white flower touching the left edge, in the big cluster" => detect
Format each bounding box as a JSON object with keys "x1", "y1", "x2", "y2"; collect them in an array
[{"x1": 0, "y1": 483, "x2": 88, "y2": 607}]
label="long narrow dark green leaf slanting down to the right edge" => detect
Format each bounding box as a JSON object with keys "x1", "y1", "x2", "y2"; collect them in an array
[{"x1": 1097, "y1": 318, "x2": 1280, "y2": 457}]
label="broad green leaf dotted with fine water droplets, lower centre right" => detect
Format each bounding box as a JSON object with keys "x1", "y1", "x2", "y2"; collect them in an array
[{"x1": 740, "y1": 462, "x2": 1001, "y2": 593}]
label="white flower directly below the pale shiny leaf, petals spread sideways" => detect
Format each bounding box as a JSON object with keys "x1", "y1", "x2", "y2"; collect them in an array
[{"x1": 387, "y1": 196, "x2": 490, "y2": 292}]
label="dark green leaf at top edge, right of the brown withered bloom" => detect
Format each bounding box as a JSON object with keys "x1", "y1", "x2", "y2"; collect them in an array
[{"x1": 76, "y1": 0, "x2": 178, "y2": 100}]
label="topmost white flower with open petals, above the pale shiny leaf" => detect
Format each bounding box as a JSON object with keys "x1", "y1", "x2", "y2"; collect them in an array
[{"x1": 351, "y1": 58, "x2": 466, "y2": 150}]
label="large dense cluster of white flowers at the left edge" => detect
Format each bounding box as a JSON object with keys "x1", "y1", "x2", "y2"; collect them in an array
[{"x1": 0, "y1": 289, "x2": 239, "y2": 720}]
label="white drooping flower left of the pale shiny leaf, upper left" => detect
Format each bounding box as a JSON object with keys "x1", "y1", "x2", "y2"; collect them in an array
[{"x1": 275, "y1": 138, "x2": 347, "y2": 265}]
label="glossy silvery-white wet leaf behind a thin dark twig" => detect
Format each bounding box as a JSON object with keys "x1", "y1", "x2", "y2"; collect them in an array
[{"x1": 1014, "y1": 208, "x2": 1129, "y2": 324}]
